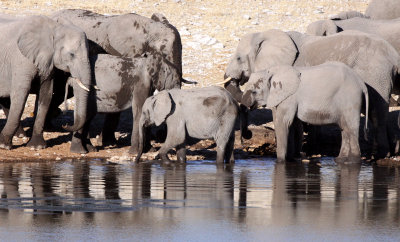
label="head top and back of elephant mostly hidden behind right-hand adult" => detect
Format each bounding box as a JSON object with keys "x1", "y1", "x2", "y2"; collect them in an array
[{"x1": 307, "y1": 17, "x2": 400, "y2": 53}]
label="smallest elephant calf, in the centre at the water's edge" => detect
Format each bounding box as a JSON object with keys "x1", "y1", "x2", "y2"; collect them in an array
[{"x1": 136, "y1": 86, "x2": 239, "y2": 164}]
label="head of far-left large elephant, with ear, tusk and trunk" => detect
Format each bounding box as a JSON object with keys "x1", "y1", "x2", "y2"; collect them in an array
[{"x1": 17, "y1": 16, "x2": 91, "y2": 131}]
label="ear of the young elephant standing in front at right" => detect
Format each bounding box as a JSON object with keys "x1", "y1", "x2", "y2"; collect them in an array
[{"x1": 267, "y1": 66, "x2": 301, "y2": 108}]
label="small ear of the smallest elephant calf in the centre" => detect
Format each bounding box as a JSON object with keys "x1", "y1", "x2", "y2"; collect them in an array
[{"x1": 153, "y1": 90, "x2": 172, "y2": 126}]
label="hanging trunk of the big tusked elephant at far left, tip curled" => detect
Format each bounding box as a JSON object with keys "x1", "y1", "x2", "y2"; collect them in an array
[{"x1": 63, "y1": 61, "x2": 92, "y2": 132}]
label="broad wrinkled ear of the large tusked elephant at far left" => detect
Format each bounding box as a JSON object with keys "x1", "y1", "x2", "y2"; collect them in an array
[{"x1": 17, "y1": 16, "x2": 57, "y2": 78}]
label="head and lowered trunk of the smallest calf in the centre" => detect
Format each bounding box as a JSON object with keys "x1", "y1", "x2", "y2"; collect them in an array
[{"x1": 135, "y1": 90, "x2": 174, "y2": 162}]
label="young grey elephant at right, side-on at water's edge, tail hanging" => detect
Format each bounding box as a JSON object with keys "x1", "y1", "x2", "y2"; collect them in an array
[{"x1": 242, "y1": 62, "x2": 368, "y2": 162}]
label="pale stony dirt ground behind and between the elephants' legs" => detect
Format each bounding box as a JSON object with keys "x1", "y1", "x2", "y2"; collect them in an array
[{"x1": 0, "y1": 0, "x2": 398, "y2": 163}]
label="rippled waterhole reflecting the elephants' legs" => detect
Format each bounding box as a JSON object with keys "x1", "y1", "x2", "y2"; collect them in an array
[{"x1": 0, "y1": 159, "x2": 400, "y2": 241}]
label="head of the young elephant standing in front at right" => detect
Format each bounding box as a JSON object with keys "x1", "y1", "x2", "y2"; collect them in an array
[{"x1": 242, "y1": 65, "x2": 301, "y2": 109}]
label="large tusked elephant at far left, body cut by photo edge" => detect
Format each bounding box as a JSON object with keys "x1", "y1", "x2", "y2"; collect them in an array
[{"x1": 0, "y1": 16, "x2": 91, "y2": 149}]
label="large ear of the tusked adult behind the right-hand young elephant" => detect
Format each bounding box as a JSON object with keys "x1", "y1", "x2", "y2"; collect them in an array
[{"x1": 249, "y1": 29, "x2": 298, "y2": 72}]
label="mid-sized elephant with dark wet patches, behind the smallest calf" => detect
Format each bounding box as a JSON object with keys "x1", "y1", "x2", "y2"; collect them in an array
[{"x1": 69, "y1": 53, "x2": 181, "y2": 153}]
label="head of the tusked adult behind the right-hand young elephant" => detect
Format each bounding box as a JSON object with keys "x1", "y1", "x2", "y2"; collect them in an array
[{"x1": 225, "y1": 29, "x2": 298, "y2": 102}]
